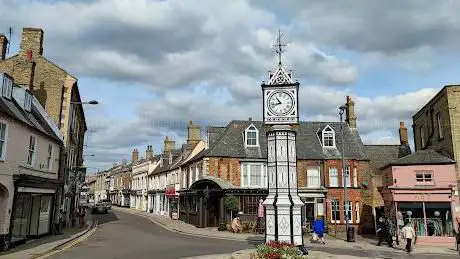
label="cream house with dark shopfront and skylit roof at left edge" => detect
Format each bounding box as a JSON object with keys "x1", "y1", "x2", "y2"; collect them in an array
[{"x1": 0, "y1": 74, "x2": 64, "y2": 249}]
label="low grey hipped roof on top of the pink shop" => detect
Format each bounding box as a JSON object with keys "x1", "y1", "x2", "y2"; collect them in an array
[{"x1": 382, "y1": 149, "x2": 455, "y2": 169}]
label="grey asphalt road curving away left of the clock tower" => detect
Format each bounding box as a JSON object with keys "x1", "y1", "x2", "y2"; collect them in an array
[{"x1": 48, "y1": 211, "x2": 253, "y2": 259}]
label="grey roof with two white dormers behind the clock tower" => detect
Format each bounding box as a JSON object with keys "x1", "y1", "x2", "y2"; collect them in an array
[{"x1": 203, "y1": 120, "x2": 369, "y2": 160}]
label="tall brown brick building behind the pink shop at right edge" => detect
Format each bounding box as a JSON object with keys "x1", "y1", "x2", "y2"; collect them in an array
[{"x1": 412, "y1": 85, "x2": 460, "y2": 189}]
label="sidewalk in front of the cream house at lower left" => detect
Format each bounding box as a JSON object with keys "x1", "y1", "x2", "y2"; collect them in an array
[{"x1": 0, "y1": 220, "x2": 94, "y2": 259}]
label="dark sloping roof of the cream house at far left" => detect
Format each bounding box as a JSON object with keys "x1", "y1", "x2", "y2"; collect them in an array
[{"x1": 0, "y1": 86, "x2": 62, "y2": 144}]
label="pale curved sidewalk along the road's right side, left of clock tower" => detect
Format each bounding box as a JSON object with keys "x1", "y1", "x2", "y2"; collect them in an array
[{"x1": 112, "y1": 207, "x2": 264, "y2": 241}]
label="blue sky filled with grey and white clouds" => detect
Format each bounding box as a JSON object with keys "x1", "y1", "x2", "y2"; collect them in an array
[{"x1": 0, "y1": 0, "x2": 460, "y2": 172}]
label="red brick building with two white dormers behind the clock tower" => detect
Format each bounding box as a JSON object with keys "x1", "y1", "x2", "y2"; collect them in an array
[{"x1": 179, "y1": 98, "x2": 370, "y2": 234}]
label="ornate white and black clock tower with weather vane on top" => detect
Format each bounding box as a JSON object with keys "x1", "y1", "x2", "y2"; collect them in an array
[{"x1": 262, "y1": 33, "x2": 305, "y2": 251}]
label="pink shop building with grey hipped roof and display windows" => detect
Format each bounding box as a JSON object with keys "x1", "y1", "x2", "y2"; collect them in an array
[{"x1": 380, "y1": 150, "x2": 459, "y2": 247}]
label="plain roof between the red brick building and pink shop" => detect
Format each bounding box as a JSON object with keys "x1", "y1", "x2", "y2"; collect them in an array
[{"x1": 365, "y1": 145, "x2": 411, "y2": 169}]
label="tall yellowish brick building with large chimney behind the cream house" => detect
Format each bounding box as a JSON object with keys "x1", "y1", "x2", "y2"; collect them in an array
[{"x1": 0, "y1": 28, "x2": 87, "y2": 228}]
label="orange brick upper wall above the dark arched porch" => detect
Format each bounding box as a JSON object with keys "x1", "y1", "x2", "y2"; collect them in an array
[{"x1": 208, "y1": 157, "x2": 241, "y2": 186}]
